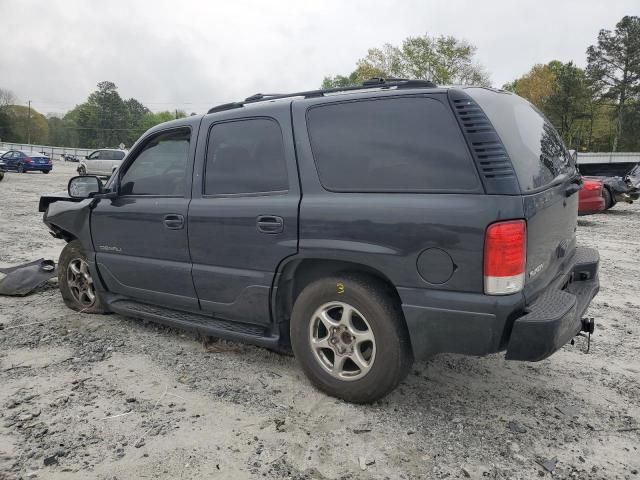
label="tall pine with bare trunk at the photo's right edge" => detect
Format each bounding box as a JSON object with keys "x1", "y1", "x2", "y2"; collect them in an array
[{"x1": 587, "y1": 16, "x2": 640, "y2": 152}]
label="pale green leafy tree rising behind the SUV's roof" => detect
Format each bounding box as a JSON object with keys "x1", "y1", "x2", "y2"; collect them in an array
[{"x1": 322, "y1": 34, "x2": 490, "y2": 88}]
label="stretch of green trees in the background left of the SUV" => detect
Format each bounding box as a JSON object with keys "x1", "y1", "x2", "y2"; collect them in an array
[{"x1": 0, "y1": 81, "x2": 186, "y2": 148}]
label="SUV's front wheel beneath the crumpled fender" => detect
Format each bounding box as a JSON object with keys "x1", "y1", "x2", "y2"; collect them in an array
[{"x1": 58, "y1": 240, "x2": 107, "y2": 313}]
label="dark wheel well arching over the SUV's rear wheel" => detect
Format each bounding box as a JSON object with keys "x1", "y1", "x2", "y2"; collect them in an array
[{"x1": 273, "y1": 259, "x2": 402, "y2": 348}]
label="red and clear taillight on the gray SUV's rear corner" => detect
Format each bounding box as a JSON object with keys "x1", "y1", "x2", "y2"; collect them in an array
[{"x1": 484, "y1": 220, "x2": 527, "y2": 295}]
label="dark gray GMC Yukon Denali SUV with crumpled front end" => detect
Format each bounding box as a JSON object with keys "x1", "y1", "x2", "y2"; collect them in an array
[{"x1": 40, "y1": 79, "x2": 599, "y2": 402}]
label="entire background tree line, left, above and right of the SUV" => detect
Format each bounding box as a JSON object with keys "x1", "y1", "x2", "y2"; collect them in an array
[{"x1": 0, "y1": 16, "x2": 640, "y2": 151}]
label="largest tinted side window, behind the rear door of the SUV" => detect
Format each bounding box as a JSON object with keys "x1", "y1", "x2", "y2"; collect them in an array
[{"x1": 307, "y1": 97, "x2": 479, "y2": 192}]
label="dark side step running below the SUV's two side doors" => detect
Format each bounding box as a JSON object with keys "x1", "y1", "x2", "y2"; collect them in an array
[{"x1": 109, "y1": 300, "x2": 279, "y2": 350}]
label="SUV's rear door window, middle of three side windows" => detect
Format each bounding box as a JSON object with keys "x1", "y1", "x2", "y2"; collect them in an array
[{"x1": 204, "y1": 118, "x2": 289, "y2": 195}]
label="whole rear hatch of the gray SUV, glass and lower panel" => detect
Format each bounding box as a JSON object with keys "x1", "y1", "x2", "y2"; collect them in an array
[{"x1": 466, "y1": 88, "x2": 580, "y2": 302}]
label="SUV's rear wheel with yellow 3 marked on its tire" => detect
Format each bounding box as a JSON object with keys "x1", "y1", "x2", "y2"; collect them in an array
[{"x1": 290, "y1": 275, "x2": 413, "y2": 403}]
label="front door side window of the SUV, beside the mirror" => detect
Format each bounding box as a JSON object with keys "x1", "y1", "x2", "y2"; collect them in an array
[{"x1": 120, "y1": 128, "x2": 191, "y2": 196}]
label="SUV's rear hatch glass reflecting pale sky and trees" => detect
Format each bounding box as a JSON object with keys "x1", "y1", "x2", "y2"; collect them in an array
[{"x1": 466, "y1": 88, "x2": 577, "y2": 192}]
